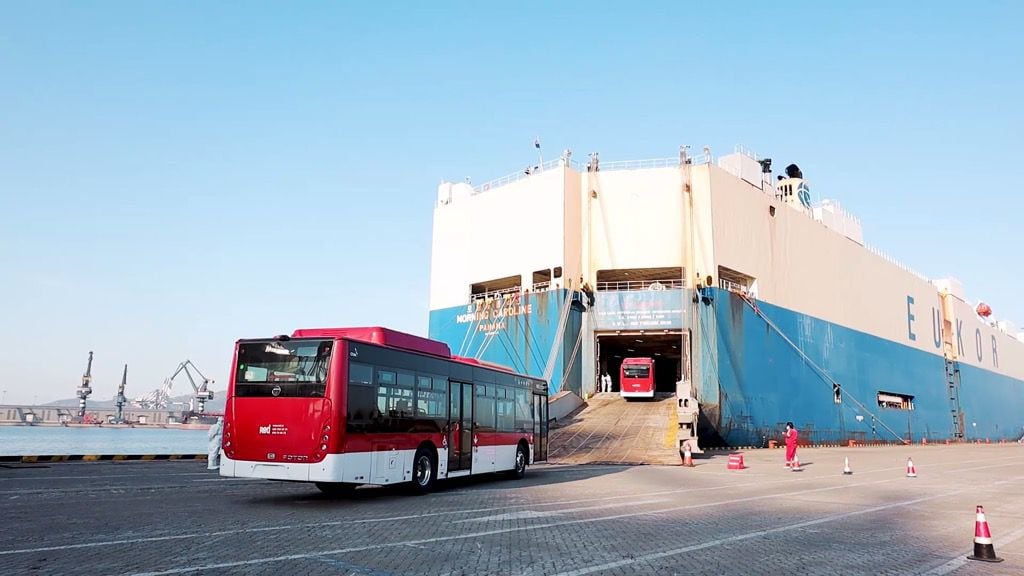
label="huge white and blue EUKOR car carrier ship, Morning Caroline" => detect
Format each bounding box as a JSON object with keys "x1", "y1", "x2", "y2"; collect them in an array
[{"x1": 429, "y1": 147, "x2": 1024, "y2": 449}]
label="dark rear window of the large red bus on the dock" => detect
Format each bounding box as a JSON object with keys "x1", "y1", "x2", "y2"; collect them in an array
[{"x1": 234, "y1": 339, "x2": 334, "y2": 397}]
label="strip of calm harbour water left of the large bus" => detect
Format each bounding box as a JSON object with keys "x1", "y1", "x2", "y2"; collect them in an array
[{"x1": 0, "y1": 426, "x2": 210, "y2": 456}]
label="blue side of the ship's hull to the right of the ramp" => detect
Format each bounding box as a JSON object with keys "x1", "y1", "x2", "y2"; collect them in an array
[{"x1": 694, "y1": 289, "x2": 1024, "y2": 446}]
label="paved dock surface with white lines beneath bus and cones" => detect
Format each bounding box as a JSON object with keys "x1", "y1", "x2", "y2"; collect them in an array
[{"x1": 0, "y1": 444, "x2": 1024, "y2": 576}]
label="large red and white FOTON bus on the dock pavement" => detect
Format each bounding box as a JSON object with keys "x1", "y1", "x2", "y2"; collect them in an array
[{"x1": 220, "y1": 327, "x2": 548, "y2": 494}]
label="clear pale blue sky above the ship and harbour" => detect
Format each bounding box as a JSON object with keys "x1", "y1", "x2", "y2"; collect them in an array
[{"x1": 0, "y1": 2, "x2": 1024, "y2": 403}]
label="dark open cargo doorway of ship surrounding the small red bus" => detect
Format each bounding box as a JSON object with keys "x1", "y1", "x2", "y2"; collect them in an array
[{"x1": 597, "y1": 331, "x2": 683, "y2": 395}]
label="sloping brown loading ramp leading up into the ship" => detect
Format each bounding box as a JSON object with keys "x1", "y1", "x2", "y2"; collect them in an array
[{"x1": 548, "y1": 393, "x2": 681, "y2": 465}]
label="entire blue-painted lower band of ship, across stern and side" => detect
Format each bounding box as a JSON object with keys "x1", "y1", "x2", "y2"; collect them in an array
[{"x1": 429, "y1": 289, "x2": 1024, "y2": 446}]
